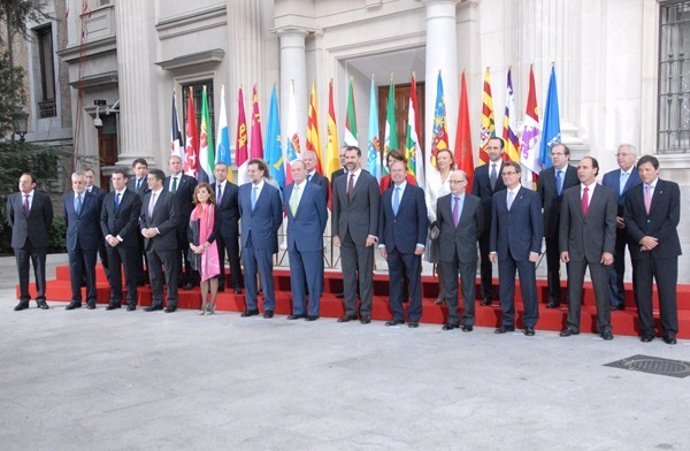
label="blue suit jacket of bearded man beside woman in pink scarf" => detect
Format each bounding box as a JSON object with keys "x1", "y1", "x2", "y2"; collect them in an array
[{"x1": 239, "y1": 182, "x2": 283, "y2": 254}]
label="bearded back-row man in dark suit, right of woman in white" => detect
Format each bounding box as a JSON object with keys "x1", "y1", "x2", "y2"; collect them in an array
[{"x1": 472, "y1": 137, "x2": 506, "y2": 305}]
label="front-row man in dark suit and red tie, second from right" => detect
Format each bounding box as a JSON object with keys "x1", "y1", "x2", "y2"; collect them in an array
[{"x1": 559, "y1": 157, "x2": 617, "y2": 340}]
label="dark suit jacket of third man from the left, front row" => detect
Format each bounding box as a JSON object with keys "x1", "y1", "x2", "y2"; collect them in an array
[{"x1": 101, "y1": 188, "x2": 141, "y2": 249}]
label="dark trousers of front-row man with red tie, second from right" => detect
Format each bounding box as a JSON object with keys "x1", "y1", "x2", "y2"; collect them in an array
[{"x1": 567, "y1": 259, "x2": 611, "y2": 333}]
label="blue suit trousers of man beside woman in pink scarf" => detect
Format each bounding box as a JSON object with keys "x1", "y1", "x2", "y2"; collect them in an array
[{"x1": 242, "y1": 242, "x2": 276, "y2": 312}]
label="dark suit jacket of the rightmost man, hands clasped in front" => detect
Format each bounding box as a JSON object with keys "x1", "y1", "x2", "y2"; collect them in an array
[{"x1": 624, "y1": 179, "x2": 681, "y2": 260}]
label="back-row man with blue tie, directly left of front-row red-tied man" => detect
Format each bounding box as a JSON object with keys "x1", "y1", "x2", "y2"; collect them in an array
[{"x1": 537, "y1": 143, "x2": 578, "y2": 308}]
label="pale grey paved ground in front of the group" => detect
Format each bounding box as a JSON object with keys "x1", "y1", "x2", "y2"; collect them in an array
[{"x1": 0, "y1": 256, "x2": 690, "y2": 451}]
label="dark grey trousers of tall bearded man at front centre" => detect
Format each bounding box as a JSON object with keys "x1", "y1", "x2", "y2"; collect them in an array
[{"x1": 340, "y1": 231, "x2": 374, "y2": 316}]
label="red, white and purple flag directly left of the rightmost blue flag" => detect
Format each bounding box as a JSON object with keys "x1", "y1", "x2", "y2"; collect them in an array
[{"x1": 520, "y1": 66, "x2": 541, "y2": 188}]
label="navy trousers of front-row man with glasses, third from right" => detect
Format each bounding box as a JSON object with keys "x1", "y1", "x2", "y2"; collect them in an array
[{"x1": 498, "y1": 255, "x2": 539, "y2": 327}]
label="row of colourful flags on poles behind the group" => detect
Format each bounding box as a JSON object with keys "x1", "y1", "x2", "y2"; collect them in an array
[{"x1": 171, "y1": 67, "x2": 560, "y2": 191}]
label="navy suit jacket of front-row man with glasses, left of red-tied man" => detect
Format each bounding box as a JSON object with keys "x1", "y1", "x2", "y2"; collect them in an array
[{"x1": 489, "y1": 187, "x2": 544, "y2": 261}]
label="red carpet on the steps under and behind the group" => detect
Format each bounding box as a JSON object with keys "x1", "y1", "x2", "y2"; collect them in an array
[{"x1": 17, "y1": 265, "x2": 690, "y2": 338}]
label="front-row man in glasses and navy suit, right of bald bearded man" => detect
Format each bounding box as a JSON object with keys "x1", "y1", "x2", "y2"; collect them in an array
[{"x1": 489, "y1": 161, "x2": 544, "y2": 337}]
